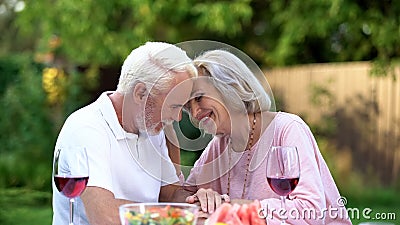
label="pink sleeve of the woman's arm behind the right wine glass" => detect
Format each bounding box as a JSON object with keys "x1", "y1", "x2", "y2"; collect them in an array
[{"x1": 261, "y1": 116, "x2": 326, "y2": 224}]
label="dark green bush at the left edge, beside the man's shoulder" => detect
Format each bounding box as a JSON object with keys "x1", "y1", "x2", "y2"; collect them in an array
[{"x1": 0, "y1": 54, "x2": 54, "y2": 188}]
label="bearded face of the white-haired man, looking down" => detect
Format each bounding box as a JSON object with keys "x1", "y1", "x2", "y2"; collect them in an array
[{"x1": 136, "y1": 72, "x2": 193, "y2": 135}]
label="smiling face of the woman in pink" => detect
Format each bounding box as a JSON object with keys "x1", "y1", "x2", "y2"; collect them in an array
[{"x1": 186, "y1": 76, "x2": 231, "y2": 135}]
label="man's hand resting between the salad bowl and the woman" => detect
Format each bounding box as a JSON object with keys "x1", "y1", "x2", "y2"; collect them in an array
[{"x1": 186, "y1": 188, "x2": 230, "y2": 214}]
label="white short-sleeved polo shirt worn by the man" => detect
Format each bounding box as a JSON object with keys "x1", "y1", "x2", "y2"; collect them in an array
[{"x1": 53, "y1": 92, "x2": 179, "y2": 225}]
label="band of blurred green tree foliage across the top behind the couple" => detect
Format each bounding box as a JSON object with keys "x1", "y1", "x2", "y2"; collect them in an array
[{"x1": 10, "y1": 0, "x2": 400, "y2": 72}]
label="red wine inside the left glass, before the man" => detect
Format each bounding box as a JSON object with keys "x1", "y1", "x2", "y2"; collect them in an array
[{"x1": 54, "y1": 176, "x2": 89, "y2": 198}]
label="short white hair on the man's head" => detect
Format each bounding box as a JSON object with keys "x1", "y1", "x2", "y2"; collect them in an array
[{"x1": 116, "y1": 42, "x2": 197, "y2": 94}]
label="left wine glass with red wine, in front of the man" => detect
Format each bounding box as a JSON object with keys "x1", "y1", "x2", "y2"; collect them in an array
[{"x1": 53, "y1": 147, "x2": 89, "y2": 225}]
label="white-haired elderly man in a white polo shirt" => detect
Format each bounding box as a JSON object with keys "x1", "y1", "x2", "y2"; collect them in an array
[{"x1": 53, "y1": 42, "x2": 221, "y2": 225}]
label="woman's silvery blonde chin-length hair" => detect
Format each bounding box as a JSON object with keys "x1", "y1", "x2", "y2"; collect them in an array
[{"x1": 194, "y1": 50, "x2": 271, "y2": 113}]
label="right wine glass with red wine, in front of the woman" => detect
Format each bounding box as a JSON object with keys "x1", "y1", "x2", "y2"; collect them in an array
[{"x1": 267, "y1": 146, "x2": 300, "y2": 224}]
